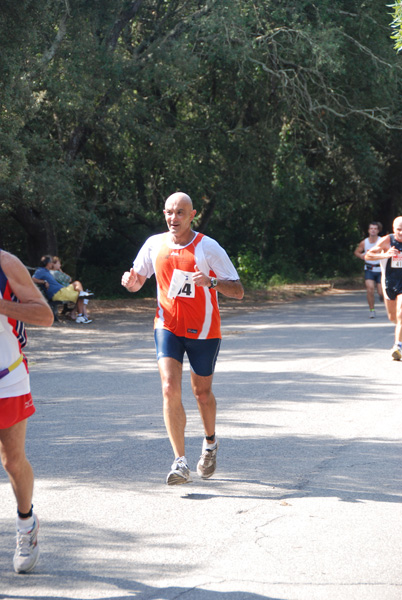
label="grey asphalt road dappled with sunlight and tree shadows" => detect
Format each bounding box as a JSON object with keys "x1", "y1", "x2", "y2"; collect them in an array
[{"x1": 0, "y1": 292, "x2": 402, "y2": 600}]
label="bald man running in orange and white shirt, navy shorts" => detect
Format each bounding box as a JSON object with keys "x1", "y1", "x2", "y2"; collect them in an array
[{"x1": 121, "y1": 192, "x2": 244, "y2": 485}]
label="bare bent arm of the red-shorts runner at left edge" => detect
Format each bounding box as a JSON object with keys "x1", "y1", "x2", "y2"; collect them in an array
[{"x1": 0, "y1": 250, "x2": 54, "y2": 327}]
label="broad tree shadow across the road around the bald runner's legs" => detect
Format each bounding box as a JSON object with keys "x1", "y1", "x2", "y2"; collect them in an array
[{"x1": 15, "y1": 294, "x2": 402, "y2": 502}]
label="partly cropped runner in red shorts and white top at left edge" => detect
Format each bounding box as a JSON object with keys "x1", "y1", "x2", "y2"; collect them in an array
[{"x1": 0, "y1": 250, "x2": 53, "y2": 573}]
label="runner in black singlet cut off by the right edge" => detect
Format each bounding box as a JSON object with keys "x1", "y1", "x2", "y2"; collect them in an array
[{"x1": 366, "y1": 217, "x2": 402, "y2": 360}]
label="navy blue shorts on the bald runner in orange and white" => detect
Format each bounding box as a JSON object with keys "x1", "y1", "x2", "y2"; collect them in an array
[{"x1": 154, "y1": 329, "x2": 221, "y2": 377}]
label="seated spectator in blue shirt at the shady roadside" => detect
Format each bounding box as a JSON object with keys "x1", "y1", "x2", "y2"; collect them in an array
[{"x1": 32, "y1": 255, "x2": 93, "y2": 323}]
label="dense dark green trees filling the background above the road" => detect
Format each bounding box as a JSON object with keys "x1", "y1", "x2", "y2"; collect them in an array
[{"x1": 0, "y1": 0, "x2": 402, "y2": 293}]
